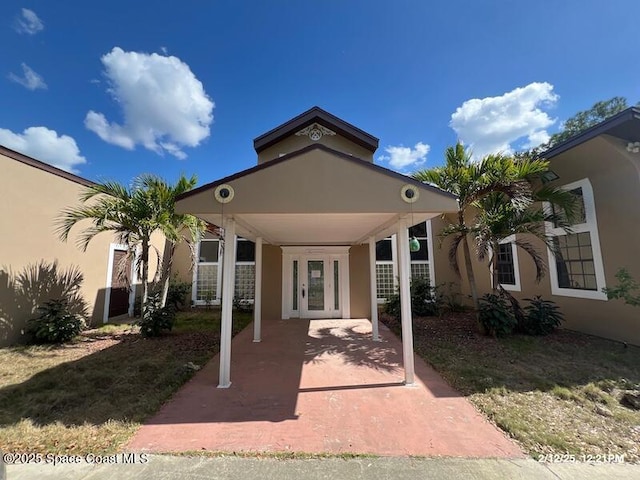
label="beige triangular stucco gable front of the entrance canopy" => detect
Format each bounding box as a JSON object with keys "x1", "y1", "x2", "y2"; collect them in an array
[{"x1": 178, "y1": 150, "x2": 456, "y2": 215}]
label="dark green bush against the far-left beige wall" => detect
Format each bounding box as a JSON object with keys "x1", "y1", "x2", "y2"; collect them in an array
[{"x1": 27, "y1": 299, "x2": 86, "y2": 344}]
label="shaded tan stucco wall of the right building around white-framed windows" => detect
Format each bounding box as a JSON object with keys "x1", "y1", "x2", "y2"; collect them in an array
[{"x1": 432, "y1": 136, "x2": 640, "y2": 345}]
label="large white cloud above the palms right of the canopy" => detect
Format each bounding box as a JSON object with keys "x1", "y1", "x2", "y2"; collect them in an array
[{"x1": 449, "y1": 82, "x2": 559, "y2": 158}]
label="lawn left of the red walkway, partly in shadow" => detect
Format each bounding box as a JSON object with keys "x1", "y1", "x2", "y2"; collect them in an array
[{"x1": 0, "y1": 310, "x2": 251, "y2": 455}]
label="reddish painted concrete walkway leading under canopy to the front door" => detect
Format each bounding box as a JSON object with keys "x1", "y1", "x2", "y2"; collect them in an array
[{"x1": 127, "y1": 320, "x2": 524, "y2": 458}]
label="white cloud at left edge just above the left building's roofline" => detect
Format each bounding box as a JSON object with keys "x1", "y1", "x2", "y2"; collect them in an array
[{"x1": 0, "y1": 127, "x2": 87, "y2": 173}]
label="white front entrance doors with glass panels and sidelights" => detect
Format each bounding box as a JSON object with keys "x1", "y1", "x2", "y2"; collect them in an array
[{"x1": 282, "y1": 247, "x2": 349, "y2": 318}]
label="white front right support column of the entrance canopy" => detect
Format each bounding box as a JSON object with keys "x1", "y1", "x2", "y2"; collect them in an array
[{"x1": 397, "y1": 219, "x2": 414, "y2": 385}]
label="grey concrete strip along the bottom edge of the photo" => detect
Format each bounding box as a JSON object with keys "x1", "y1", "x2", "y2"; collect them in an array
[{"x1": 7, "y1": 455, "x2": 640, "y2": 480}]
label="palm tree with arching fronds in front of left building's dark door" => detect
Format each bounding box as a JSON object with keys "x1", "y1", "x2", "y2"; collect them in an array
[{"x1": 57, "y1": 174, "x2": 203, "y2": 316}]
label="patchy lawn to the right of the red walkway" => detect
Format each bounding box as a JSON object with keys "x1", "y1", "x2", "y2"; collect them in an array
[{"x1": 382, "y1": 314, "x2": 640, "y2": 463}]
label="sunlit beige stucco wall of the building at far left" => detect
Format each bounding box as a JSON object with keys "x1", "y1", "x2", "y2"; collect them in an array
[{"x1": 0, "y1": 154, "x2": 113, "y2": 344}]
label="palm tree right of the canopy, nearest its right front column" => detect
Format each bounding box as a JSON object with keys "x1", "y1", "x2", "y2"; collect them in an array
[{"x1": 412, "y1": 142, "x2": 548, "y2": 311}]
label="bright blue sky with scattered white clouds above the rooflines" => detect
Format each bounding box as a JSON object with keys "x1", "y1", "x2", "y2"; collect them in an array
[{"x1": 0, "y1": 0, "x2": 640, "y2": 183}]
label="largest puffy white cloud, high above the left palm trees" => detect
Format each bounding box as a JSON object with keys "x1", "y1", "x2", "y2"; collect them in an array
[{"x1": 84, "y1": 47, "x2": 214, "y2": 158}]
